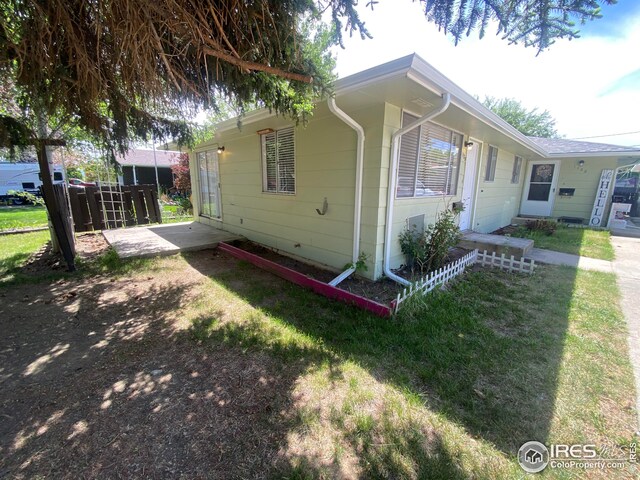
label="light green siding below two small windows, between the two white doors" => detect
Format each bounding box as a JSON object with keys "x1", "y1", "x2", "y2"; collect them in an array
[{"x1": 473, "y1": 143, "x2": 526, "y2": 233}]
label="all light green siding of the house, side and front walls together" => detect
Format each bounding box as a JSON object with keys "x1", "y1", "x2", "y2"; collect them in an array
[{"x1": 191, "y1": 100, "x2": 618, "y2": 279}]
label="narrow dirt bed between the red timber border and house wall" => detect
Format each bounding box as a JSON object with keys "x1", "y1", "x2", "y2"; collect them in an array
[{"x1": 231, "y1": 240, "x2": 402, "y2": 305}]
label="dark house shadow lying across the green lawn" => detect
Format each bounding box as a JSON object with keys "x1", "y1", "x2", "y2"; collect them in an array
[{"x1": 186, "y1": 255, "x2": 576, "y2": 468}]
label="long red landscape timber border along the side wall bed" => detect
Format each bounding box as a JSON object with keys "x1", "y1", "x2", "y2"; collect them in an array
[{"x1": 218, "y1": 242, "x2": 393, "y2": 317}]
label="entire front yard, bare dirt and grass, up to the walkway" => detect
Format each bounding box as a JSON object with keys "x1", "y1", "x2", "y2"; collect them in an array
[{"x1": 0, "y1": 251, "x2": 638, "y2": 479}]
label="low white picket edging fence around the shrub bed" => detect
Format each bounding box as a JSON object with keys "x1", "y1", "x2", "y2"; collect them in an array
[{"x1": 393, "y1": 249, "x2": 535, "y2": 313}]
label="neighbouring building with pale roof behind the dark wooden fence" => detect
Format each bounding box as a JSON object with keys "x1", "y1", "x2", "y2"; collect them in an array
[{"x1": 116, "y1": 148, "x2": 180, "y2": 190}]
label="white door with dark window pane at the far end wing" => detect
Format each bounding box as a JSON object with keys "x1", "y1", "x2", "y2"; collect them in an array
[{"x1": 520, "y1": 160, "x2": 560, "y2": 217}]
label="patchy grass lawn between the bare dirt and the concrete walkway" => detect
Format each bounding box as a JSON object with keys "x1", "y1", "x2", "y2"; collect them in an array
[{"x1": 179, "y1": 258, "x2": 635, "y2": 478}]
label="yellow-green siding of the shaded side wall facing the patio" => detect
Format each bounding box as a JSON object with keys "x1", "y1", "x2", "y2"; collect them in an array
[{"x1": 192, "y1": 104, "x2": 384, "y2": 276}]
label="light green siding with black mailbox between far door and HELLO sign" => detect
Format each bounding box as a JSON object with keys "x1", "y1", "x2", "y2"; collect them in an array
[{"x1": 552, "y1": 157, "x2": 618, "y2": 224}]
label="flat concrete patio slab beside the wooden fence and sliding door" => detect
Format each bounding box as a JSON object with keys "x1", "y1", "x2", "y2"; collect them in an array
[{"x1": 102, "y1": 222, "x2": 240, "y2": 258}]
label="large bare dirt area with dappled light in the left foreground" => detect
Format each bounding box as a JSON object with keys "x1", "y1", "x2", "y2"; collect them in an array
[{"x1": 0, "y1": 253, "x2": 297, "y2": 479}]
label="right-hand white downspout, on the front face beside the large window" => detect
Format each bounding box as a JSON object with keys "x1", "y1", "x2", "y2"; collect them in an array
[{"x1": 382, "y1": 93, "x2": 451, "y2": 285}]
